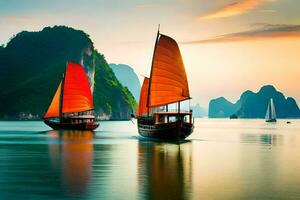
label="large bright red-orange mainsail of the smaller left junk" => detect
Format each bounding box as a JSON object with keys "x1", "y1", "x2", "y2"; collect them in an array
[{"x1": 62, "y1": 62, "x2": 93, "y2": 113}]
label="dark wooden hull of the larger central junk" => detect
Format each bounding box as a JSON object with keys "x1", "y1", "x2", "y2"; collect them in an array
[{"x1": 138, "y1": 122, "x2": 194, "y2": 141}]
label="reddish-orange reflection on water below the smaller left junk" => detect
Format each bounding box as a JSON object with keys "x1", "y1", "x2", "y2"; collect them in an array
[{"x1": 47, "y1": 130, "x2": 94, "y2": 196}]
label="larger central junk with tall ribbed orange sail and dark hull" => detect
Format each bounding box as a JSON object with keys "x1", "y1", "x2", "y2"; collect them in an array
[{"x1": 137, "y1": 27, "x2": 194, "y2": 141}]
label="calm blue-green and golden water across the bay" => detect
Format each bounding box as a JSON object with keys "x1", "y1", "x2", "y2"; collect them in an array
[{"x1": 0, "y1": 119, "x2": 300, "y2": 200}]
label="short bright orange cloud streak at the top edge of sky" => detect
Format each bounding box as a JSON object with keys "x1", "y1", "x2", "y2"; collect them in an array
[{"x1": 197, "y1": 0, "x2": 271, "y2": 19}]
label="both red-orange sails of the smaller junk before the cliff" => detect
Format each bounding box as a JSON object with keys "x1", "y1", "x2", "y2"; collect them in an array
[{"x1": 44, "y1": 62, "x2": 93, "y2": 118}]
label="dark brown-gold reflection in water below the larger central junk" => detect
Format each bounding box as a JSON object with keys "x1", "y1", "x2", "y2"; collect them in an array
[{"x1": 138, "y1": 141, "x2": 192, "y2": 199}]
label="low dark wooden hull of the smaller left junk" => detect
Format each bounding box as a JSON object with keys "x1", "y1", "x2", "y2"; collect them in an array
[{"x1": 44, "y1": 120, "x2": 99, "y2": 130}]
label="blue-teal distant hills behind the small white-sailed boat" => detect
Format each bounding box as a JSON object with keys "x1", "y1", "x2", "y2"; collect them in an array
[{"x1": 208, "y1": 85, "x2": 300, "y2": 118}]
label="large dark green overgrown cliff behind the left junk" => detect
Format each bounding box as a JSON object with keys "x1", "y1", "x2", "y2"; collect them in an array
[{"x1": 0, "y1": 26, "x2": 136, "y2": 119}]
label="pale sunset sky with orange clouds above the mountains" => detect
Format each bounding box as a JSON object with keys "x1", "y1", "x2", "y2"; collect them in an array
[{"x1": 0, "y1": 0, "x2": 300, "y2": 107}]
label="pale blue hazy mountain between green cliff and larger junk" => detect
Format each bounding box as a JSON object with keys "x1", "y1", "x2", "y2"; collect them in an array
[{"x1": 109, "y1": 63, "x2": 141, "y2": 101}]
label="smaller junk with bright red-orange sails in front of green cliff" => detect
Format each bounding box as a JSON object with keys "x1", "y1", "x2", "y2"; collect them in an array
[{"x1": 44, "y1": 62, "x2": 99, "y2": 130}]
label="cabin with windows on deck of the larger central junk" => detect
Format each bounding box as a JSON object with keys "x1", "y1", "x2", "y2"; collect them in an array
[{"x1": 154, "y1": 111, "x2": 193, "y2": 124}]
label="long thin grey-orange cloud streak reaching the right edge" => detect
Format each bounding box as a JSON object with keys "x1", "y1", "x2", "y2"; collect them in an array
[{"x1": 181, "y1": 23, "x2": 300, "y2": 44}]
